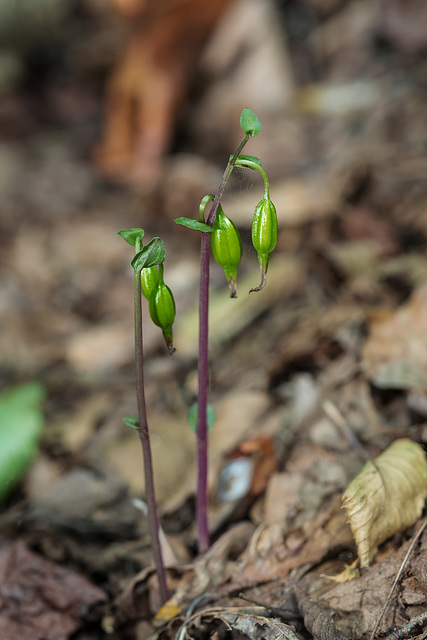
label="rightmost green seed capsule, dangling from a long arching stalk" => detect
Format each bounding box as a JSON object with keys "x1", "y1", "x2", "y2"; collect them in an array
[{"x1": 249, "y1": 195, "x2": 277, "y2": 293}]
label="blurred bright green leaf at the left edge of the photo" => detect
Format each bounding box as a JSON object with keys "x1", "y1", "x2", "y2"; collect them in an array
[{"x1": 0, "y1": 382, "x2": 45, "y2": 500}]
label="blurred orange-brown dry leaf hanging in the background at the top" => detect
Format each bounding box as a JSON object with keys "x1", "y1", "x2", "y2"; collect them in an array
[{"x1": 95, "y1": 0, "x2": 236, "y2": 185}]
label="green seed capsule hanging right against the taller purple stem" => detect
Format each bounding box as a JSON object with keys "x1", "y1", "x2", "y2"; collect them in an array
[{"x1": 210, "y1": 205, "x2": 242, "y2": 298}]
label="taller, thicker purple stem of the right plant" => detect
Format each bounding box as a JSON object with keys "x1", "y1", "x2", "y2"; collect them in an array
[{"x1": 196, "y1": 136, "x2": 249, "y2": 553}]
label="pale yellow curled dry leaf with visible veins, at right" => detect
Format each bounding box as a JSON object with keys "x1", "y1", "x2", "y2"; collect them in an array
[{"x1": 342, "y1": 438, "x2": 427, "y2": 567}]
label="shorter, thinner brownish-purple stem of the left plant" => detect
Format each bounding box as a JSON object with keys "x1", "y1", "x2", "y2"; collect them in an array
[{"x1": 134, "y1": 242, "x2": 169, "y2": 603}]
